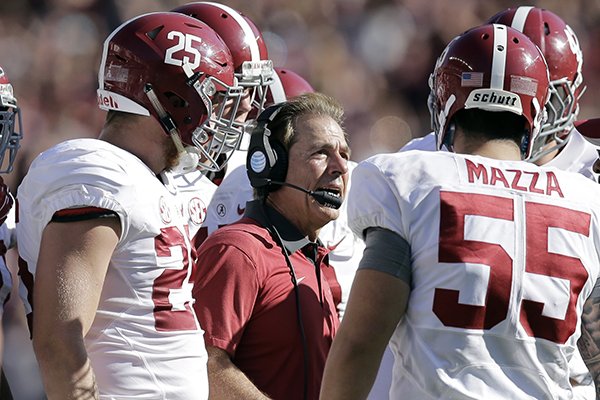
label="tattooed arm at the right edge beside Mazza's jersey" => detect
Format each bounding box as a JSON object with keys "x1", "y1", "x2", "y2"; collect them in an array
[{"x1": 577, "y1": 284, "x2": 600, "y2": 398}]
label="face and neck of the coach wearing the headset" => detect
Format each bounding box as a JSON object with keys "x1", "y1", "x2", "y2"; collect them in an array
[{"x1": 269, "y1": 114, "x2": 350, "y2": 240}]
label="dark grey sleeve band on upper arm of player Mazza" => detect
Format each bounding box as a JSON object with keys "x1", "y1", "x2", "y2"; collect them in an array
[{"x1": 358, "y1": 228, "x2": 412, "y2": 285}]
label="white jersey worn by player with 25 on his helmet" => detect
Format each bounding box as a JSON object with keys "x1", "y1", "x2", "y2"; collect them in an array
[{"x1": 17, "y1": 139, "x2": 208, "y2": 400}]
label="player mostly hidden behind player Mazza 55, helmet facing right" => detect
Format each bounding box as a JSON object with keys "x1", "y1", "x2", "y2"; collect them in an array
[{"x1": 401, "y1": 6, "x2": 600, "y2": 392}]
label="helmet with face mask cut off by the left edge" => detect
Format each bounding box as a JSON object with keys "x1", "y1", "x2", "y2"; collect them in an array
[{"x1": 0, "y1": 67, "x2": 23, "y2": 173}]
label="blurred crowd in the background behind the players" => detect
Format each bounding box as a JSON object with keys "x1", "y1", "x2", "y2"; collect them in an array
[{"x1": 0, "y1": 0, "x2": 600, "y2": 399}]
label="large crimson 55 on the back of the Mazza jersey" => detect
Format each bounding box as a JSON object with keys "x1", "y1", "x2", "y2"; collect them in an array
[{"x1": 433, "y1": 192, "x2": 590, "y2": 343}]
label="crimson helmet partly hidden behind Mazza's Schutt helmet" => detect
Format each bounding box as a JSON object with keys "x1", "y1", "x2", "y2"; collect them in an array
[{"x1": 488, "y1": 6, "x2": 585, "y2": 161}]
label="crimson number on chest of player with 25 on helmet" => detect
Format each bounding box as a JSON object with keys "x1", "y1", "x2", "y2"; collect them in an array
[{"x1": 152, "y1": 226, "x2": 198, "y2": 331}]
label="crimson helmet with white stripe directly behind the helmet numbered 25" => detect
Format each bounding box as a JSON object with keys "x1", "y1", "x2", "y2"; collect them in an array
[{"x1": 172, "y1": 1, "x2": 274, "y2": 114}]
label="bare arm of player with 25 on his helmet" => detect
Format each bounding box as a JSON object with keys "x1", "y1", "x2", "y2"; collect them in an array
[{"x1": 33, "y1": 216, "x2": 121, "y2": 400}]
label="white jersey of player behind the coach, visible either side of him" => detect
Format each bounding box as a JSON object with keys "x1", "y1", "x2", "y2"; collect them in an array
[{"x1": 203, "y1": 161, "x2": 365, "y2": 316}]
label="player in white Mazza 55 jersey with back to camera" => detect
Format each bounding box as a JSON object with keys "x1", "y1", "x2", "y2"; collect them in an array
[{"x1": 321, "y1": 24, "x2": 600, "y2": 399}]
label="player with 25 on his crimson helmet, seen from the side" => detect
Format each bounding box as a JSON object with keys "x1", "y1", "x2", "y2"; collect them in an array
[{"x1": 17, "y1": 13, "x2": 242, "y2": 400}]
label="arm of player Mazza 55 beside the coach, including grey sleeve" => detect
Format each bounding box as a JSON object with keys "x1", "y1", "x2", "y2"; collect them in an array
[{"x1": 320, "y1": 228, "x2": 410, "y2": 400}]
